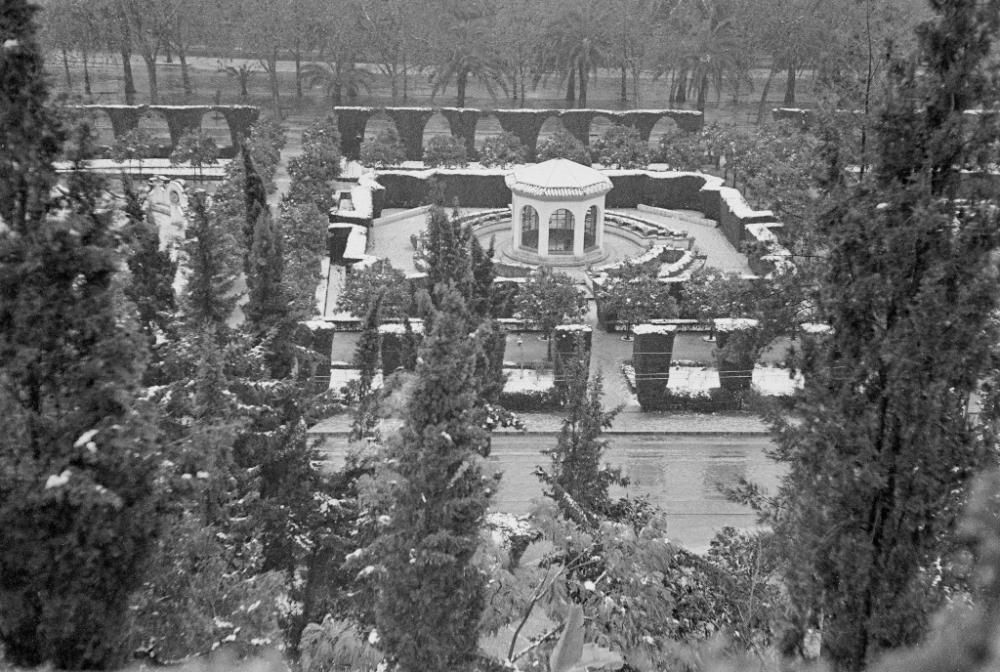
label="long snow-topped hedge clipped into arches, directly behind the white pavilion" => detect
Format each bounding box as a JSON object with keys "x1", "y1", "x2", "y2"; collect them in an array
[{"x1": 333, "y1": 106, "x2": 705, "y2": 161}]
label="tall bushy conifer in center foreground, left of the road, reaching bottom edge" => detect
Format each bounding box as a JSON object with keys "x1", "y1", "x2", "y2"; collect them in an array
[{"x1": 375, "y1": 289, "x2": 496, "y2": 672}]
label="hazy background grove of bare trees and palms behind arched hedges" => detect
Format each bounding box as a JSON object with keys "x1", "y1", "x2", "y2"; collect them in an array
[{"x1": 41, "y1": 0, "x2": 923, "y2": 111}]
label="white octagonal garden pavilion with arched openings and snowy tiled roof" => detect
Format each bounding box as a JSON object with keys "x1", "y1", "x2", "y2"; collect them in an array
[{"x1": 506, "y1": 159, "x2": 612, "y2": 265}]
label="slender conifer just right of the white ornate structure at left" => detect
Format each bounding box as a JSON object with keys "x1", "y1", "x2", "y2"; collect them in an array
[{"x1": 182, "y1": 191, "x2": 239, "y2": 329}]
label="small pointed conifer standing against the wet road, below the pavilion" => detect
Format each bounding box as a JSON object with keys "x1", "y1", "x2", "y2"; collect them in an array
[{"x1": 535, "y1": 359, "x2": 627, "y2": 523}]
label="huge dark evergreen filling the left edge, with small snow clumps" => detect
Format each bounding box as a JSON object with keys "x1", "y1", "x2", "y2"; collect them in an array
[{"x1": 0, "y1": 5, "x2": 160, "y2": 669}]
